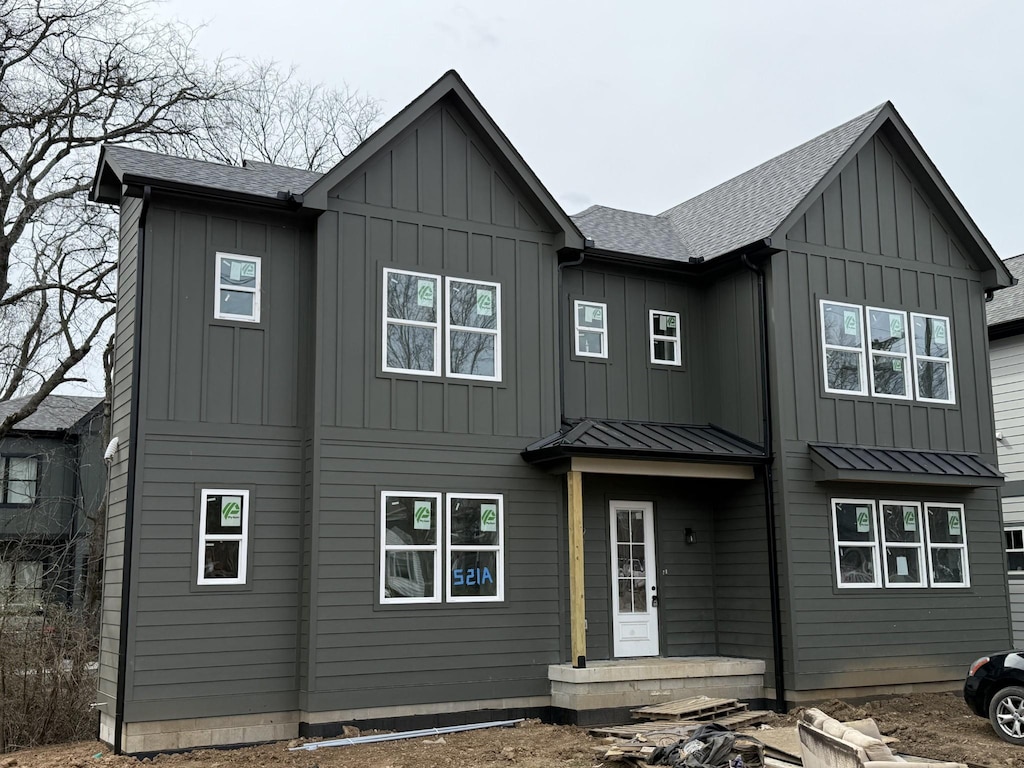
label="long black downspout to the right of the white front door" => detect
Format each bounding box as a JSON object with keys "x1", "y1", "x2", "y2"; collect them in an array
[{"x1": 740, "y1": 253, "x2": 785, "y2": 712}]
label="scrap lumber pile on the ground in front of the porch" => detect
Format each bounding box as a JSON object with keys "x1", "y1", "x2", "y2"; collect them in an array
[{"x1": 590, "y1": 696, "x2": 768, "y2": 768}]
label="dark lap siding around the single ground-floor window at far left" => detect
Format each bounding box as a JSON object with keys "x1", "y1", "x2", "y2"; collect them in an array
[{"x1": 126, "y1": 436, "x2": 303, "y2": 721}]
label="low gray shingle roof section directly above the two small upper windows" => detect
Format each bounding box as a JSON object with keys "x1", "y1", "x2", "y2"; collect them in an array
[{"x1": 570, "y1": 206, "x2": 689, "y2": 261}]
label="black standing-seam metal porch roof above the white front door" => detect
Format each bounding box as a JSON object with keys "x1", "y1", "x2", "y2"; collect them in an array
[{"x1": 523, "y1": 419, "x2": 765, "y2": 464}]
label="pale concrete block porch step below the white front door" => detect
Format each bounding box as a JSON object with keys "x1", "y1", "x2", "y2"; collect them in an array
[{"x1": 548, "y1": 656, "x2": 765, "y2": 725}]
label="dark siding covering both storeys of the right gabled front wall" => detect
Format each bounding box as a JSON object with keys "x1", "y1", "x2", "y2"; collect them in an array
[{"x1": 769, "y1": 129, "x2": 1009, "y2": 690}]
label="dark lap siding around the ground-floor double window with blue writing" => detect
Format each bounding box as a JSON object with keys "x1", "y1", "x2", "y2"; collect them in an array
[{"x1": 308, "y1": 442, "x2": 564, "y2": 710}]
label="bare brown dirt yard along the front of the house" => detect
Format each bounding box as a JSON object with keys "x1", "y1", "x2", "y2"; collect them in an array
[{"x1": 8, "y1": 693, "x2": 1024, "y2": 768}]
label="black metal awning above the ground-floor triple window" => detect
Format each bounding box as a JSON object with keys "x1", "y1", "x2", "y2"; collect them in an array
[{"x1": 808, "y1": 442, "x2": 1002, "y2": 487}]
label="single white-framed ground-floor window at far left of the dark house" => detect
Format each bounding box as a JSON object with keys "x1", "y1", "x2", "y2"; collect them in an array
[{"x1": 199, "y1": 488, "x2": 249, "y2": 585}]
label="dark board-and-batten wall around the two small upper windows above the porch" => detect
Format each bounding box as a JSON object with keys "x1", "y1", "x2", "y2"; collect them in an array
[{"x1": 559, "y1": 266, "x2": 701, "y2": 423}]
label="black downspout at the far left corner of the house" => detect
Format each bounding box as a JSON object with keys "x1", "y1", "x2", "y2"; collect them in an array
[{"x1": 114, "y1": 184, "x2": 153, "y2": 755}]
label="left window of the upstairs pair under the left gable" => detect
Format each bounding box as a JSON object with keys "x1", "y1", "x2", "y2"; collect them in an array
[{"x1": 381, "y1": 269, "x2": 441, "y2": 376}]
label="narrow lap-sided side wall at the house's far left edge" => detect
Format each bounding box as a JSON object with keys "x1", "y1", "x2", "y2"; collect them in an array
[{"x1": 97, "y1": 198, "x2": 142, "y2": 718}]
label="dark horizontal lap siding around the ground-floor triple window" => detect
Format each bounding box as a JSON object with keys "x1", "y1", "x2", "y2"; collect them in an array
[{"x1": 784, "y1": 443, "x2": 1010, "y2": 690}]
